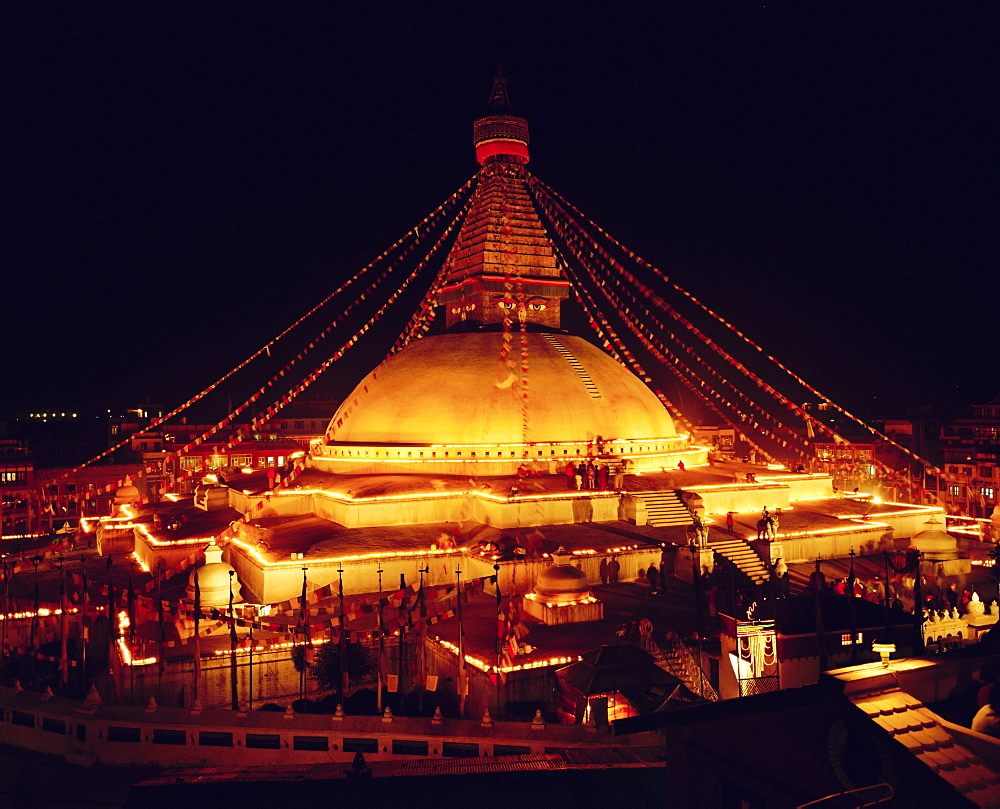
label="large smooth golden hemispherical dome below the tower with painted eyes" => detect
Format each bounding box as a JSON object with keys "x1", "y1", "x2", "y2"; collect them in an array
[{"x1": 327, "y1": 332, "x2": 677, "y2": 445}]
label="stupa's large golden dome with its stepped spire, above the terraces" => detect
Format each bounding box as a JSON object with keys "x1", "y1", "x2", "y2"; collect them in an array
[{"x1": 313, "y1": 71, "x2": 707, "y2": 476}]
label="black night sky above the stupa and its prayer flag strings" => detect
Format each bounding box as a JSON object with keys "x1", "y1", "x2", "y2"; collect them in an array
[{"x1": 0, "y1": 0, "x2": 1000, "y2": 422}]
